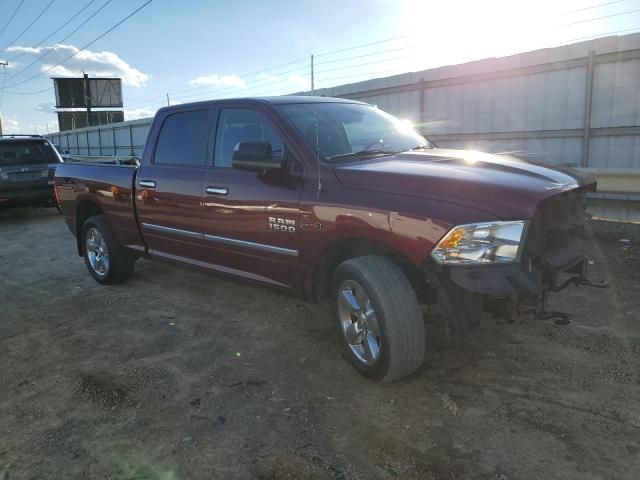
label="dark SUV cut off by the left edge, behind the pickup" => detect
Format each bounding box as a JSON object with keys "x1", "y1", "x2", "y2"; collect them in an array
[{"x1": 0, "y1": 135, "x2": 62, "y2": 207}]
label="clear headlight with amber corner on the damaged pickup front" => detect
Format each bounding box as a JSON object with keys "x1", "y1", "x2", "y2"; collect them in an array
[{"x1": 431, "y1": 221, "x2": 527, "y2": 265}]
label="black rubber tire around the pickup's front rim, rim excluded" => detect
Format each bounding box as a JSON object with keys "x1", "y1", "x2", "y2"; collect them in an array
[{"x1": 332, "y1": 255, "x2": 426, "y2": 383}]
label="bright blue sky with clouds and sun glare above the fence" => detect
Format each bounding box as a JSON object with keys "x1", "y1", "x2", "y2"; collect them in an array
[{"x1": 0, "y1": 0, "x2": 640, "y2": 134}]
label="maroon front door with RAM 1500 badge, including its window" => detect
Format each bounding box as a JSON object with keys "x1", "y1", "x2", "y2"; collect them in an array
[{"x1": 202, "y1": 106, "x2": 303, "y2": 287}]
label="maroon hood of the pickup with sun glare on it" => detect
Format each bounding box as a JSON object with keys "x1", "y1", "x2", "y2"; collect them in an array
[{"x1": 334, "y1": 148, "x2": 595, "y2": 220}]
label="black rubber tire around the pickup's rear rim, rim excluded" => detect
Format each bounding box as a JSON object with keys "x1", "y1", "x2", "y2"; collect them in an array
[{"x1": 81, "y1": 215, "x2": 135, "y2": 285}]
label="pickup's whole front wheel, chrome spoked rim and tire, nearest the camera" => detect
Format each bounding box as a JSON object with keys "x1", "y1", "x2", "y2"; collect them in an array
[{"x1": 332, "y1": 255, "x2": 425, "y2": 382}]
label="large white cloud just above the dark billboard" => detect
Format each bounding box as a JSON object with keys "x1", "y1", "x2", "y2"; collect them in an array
[{"x1": 7, "y1": 44, "x2": 150, "y2": 87}]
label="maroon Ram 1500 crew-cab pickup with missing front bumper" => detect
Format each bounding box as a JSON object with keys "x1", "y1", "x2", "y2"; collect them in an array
[{"x1": 55, "y1": 96, "x2": 595, "y2": 381}]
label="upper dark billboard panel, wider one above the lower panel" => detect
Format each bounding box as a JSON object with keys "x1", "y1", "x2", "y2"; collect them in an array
[{"x1": 53, "y1": 77, "x2": 123, "y2": 108}]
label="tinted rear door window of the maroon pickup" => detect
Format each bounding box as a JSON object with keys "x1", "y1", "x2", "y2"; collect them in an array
[{"x1": 154, "y1": 110, "x2": 210, "y2": 166}]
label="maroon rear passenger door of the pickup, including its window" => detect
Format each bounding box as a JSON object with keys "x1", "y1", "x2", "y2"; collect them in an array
[{"x1": 136, "y1": 108, "x2": 212, "y2": 263}]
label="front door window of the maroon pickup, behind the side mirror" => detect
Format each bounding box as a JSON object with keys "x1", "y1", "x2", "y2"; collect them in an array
[{"x1": 214, "y1": 108, "x2": 283, "y2": 167}]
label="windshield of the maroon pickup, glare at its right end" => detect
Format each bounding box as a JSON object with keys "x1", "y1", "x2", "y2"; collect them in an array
[{"x1": 279, "y1": 103, "x2": 433, "y2": 163}]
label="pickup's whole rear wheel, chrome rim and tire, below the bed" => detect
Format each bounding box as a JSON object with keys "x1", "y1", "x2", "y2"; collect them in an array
[{"x1": 82, "y1": 215, "x2": 135, "y2": 285}]
